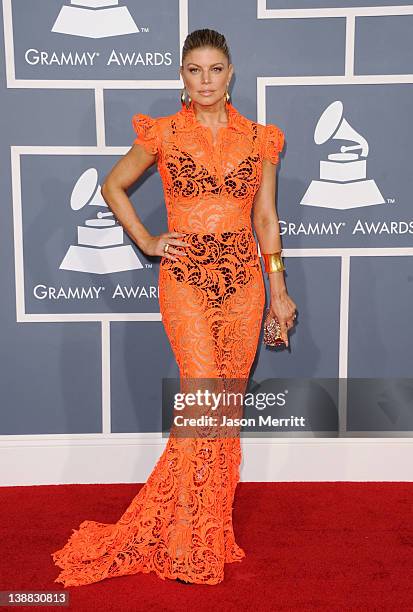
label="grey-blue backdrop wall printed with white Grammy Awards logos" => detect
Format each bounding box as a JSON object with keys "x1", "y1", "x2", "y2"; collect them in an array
[{"x1": 0, "y1": 0, "x2": 413, "y2": 437}]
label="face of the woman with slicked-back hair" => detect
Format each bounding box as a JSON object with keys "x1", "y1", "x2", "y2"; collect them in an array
[{"x1": 180, "y1": 47, "x2": 233, "y2": 106}]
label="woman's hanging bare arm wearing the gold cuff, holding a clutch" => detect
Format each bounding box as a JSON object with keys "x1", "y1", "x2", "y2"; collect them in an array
[{"x1": 253, "y1": 159, "x2": 296, "y2": 346}]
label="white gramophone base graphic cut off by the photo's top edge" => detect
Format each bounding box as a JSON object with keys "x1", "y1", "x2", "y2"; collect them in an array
[{"x1": 52, "y1": 0, "x2": 139, "y2": 38}]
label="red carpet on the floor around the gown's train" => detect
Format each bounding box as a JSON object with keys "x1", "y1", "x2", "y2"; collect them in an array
[{"x1": 0, "y1": 482, "x2": 413, "y2": 612}]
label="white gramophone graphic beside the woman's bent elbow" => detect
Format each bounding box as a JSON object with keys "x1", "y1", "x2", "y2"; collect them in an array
[{"x1": 59, "y1": 168, "x2": 143, "y2": 274}]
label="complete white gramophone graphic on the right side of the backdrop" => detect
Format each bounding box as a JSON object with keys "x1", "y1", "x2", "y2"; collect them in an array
[{"x1": 300, "y1": 100, "x2": 385, "y2": 210}]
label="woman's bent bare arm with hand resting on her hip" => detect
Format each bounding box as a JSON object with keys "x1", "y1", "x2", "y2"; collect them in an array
[{"x1": 101, "y1": 144, "x2": 187, "y2": 260}]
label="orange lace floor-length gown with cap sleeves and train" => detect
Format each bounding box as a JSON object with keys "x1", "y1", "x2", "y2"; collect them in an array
[{"x1": 52, "y1": 102, "x2": 284, "y2": 587}]
